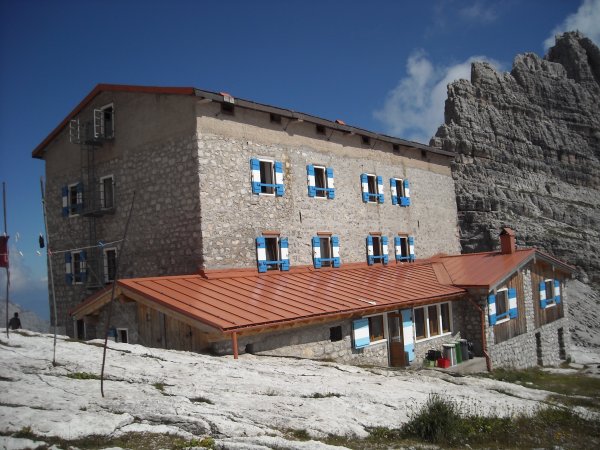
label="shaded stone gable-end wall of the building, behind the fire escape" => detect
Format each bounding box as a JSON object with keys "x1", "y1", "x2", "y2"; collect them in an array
[{"x1": 45, "y1": 93, "x2": 201, "y2": 335}]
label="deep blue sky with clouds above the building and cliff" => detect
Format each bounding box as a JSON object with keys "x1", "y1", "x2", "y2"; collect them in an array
[{"x1": 0, "y1": 0, "x2": 600, "y2": 317}]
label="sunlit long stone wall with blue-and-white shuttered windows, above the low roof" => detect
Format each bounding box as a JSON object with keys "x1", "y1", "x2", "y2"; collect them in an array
[{"x1": 197, "y1": 103, "x2": 460, "y2": 268}]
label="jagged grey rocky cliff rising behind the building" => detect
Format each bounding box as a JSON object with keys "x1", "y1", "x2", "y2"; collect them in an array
[{"x1": 431, "y1": 33, "x2": 600, "y2": 286}]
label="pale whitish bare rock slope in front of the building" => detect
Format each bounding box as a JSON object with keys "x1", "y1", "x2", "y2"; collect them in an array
[{"x1": 0, "y1": 331, "x2": 600, "y2": 449}]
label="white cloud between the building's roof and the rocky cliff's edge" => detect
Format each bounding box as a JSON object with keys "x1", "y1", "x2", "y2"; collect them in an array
[{"x1": 374, "y1": 50, "x2": 500, "y2": 144}]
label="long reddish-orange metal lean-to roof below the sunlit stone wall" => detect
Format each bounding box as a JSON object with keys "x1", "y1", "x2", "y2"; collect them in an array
[{"x1": 72, "y1": 264, "x2": 465, "y2": 331}]
